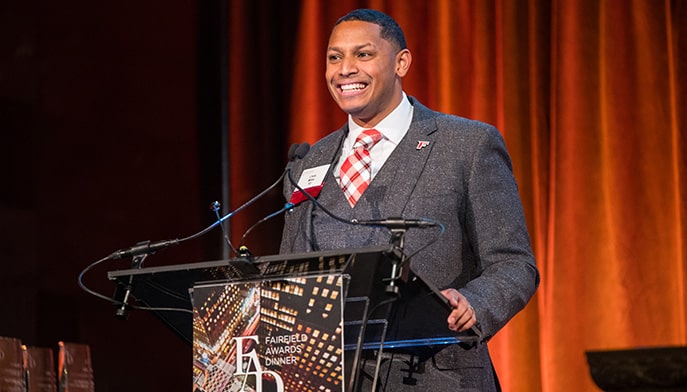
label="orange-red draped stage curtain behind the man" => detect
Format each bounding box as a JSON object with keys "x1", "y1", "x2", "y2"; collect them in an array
[{"x1": 230, "y1": 0, "x2": 687, "y2": 392}]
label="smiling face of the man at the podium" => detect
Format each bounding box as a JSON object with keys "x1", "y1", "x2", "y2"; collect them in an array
[{"x1": 325, "y1": 21, "x2": 410, "y2": 127}]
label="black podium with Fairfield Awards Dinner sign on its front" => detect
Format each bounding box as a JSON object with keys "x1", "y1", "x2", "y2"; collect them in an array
[{"x1": 108, "y1": 245, "x2": 480, "y2": 392}]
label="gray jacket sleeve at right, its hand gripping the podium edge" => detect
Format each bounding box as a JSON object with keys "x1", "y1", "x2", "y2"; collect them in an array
[{"x1": 459, "y1": 127, "x2": 539, "y2": 337}]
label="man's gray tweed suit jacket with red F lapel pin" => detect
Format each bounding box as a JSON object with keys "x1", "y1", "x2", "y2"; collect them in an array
[{"x1": 280, "y1": 97, "x2": 539, "y2": 390}]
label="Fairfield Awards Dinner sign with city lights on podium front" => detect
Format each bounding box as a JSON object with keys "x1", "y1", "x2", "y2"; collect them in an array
[{"x1": 191, "y1": 274, "x2": 347, "y2": 392}]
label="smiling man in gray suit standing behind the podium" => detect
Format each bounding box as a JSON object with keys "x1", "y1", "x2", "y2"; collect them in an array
[{"x1": 281, "y1": 10, "x2": 539, "y2": 391}]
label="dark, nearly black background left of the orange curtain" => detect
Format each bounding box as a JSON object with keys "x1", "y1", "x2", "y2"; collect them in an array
[{"x1": 0, "y1": 0, "x2": 296, "y2": 392}]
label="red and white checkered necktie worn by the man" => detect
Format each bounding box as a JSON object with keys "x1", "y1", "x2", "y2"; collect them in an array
[{"x1": 340, "y1": 129, "x2": 382, "y2": 207}]
